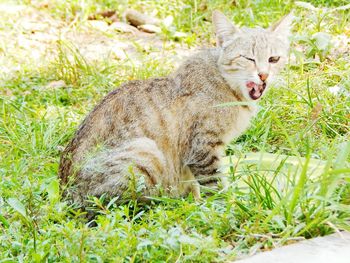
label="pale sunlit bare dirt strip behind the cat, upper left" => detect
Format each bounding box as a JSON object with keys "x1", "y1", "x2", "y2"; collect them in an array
[{"x1": 0, "y1": 4, "x2": 191, "y2": 77}]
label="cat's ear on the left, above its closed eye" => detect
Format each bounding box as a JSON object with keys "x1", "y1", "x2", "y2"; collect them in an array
[{"x1": 213, "y1": 10, "x2": 240, "y2": 47}]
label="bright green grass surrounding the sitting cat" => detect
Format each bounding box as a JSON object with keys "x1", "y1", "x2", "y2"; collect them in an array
[{"x1": 0, "y1": 0, "x2": 350, "y2": 262}]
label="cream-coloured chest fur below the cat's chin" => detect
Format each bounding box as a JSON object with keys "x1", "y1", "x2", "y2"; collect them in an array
[{"x1": 223, "y1": 107, "x2": 257, "y2": 144}]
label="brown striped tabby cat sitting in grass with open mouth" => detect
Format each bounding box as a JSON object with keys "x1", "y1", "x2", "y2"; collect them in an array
[{"x1": 59, "y1": 11, "x2": 293, "y2": 205}]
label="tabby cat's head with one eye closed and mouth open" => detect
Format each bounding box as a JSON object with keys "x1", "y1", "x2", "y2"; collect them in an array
[{"x1": 213, "y1": 11, "x2": 293, "y2": 100}]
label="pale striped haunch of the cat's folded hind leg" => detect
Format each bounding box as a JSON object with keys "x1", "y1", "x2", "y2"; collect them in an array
[{"x1": 68, "y1": 137, "x2": 169, "y2": 204}]
